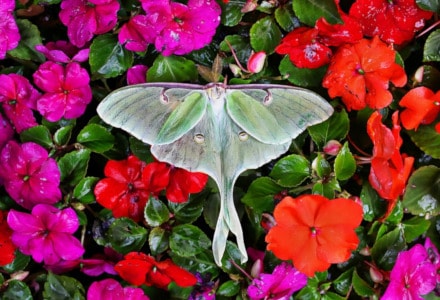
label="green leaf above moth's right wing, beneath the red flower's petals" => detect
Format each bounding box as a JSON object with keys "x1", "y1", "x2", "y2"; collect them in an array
[{"x1": 279, "y1": 55, "x2": 327, "y2": 87}]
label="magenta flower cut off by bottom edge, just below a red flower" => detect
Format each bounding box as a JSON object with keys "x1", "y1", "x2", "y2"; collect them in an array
[{"x1": 87, "y1": 278, "x2": 150, "y2": 300}]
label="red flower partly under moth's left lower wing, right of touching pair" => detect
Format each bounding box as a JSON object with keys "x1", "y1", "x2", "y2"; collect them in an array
[{"x1": 142, "y1": 162, "x2": 208, "y2": 203}]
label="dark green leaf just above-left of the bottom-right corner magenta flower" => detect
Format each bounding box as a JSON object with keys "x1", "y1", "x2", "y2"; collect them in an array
[{"x1": 371, "y1": 227, "x2": 406, "y2": 271}]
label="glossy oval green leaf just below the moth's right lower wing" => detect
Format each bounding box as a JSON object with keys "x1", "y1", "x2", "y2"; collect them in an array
[{"x1": 269, "y1": 154, "x2": 310, "y2": 187}]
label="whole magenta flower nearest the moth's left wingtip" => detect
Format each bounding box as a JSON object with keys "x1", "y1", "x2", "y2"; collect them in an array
[{"x1": 34, "y1": 61, "x2": 92, "y2": 122}]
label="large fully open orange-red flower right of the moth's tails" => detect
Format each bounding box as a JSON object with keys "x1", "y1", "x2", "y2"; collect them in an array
[{"x1": 266, "y1": 195, "x2": 363, "y2": 276}]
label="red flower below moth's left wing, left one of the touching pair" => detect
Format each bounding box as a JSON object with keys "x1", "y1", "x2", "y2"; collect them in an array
[{"x1": 95, "y1": 155, "x2": 150, "y2": 222}]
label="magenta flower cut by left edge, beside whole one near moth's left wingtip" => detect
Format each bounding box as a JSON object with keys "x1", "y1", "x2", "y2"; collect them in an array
[{"x1": 0, "y1": 74, "x2": 40, "y2": 133}]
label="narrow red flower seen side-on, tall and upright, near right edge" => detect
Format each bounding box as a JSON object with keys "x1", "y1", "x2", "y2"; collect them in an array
[{"x1": 367, "y1": 111, "x2": 414, "y2": 214}]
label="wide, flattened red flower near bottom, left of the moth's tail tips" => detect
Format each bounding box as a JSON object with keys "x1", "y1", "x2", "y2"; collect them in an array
[{"x1": 115, "y1": 252, "x2": 197, "y2": 290}]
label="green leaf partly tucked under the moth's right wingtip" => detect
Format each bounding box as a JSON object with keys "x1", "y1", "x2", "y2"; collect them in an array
[{"x1": 307, "y1": 109, "x2": 350, "y2": 149}]
